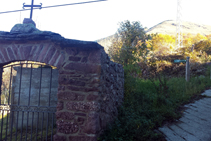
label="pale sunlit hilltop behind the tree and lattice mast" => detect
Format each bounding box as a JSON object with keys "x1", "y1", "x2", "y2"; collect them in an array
[{"x1": 96, "y1": 20, "x2": 211, "y2": 52}]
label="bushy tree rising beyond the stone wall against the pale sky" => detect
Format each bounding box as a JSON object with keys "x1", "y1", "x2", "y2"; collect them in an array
[{"x1": 109, "y1": 21, "x2": 148, "y2": 66}]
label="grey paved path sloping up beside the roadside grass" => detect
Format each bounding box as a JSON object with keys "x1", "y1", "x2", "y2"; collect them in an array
[{"x1": 158, "y1": 90, "x2": 211, "y2": 141}]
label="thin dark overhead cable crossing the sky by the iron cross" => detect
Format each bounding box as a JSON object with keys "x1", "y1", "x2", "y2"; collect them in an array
[{"x1": 0, "y1": 0, "x2": 107, "y2": 14}]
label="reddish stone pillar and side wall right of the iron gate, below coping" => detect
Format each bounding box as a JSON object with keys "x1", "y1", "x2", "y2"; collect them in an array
[{"x1": 55, "y1": 49, "x2": 124, "y2": 141}]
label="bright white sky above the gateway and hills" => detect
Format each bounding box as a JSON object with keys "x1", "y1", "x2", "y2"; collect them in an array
[{"x1": 0, "y1": 0, "x2": 211, "y2": 41}]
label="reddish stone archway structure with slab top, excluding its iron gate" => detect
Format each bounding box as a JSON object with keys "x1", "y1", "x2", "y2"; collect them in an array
[{"x1": 0, "y1": 19, "x2": 124, "y2": 141}]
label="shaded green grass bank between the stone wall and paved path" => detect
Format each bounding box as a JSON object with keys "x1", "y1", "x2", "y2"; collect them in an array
[{"x1": 99, "y1": 76, "x2": 211, "y2": 141}]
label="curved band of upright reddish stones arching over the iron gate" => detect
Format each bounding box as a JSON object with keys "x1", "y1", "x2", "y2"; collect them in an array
[{"x1": 0, "y1": 43, "x2": 65, "y2": 69}]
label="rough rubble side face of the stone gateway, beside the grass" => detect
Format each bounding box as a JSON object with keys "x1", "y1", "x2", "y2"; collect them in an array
[{"x1": 99, "y1": 52, "x2": 124, "y2": 129}]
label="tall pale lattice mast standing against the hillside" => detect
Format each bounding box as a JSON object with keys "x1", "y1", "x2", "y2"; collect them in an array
[{"x1": 175, "y1": 0, "x2": 183, "y2": 50}]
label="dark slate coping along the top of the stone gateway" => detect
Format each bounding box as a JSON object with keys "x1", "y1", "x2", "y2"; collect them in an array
[{"x1": 0, "y1": 31, "x2": 104, "y2": 49}]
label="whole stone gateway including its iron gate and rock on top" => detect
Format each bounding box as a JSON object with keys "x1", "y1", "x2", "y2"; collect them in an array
[{"x1": 0, "y1": 21, "x2": 124, "y2": 141}]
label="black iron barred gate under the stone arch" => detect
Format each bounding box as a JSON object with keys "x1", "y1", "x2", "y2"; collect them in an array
[{"x1": 0, "y1": 61, "x2": 58, "y2": 141}]
